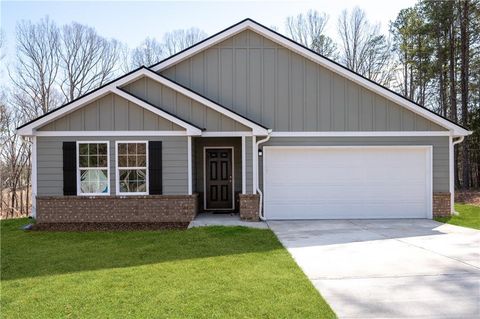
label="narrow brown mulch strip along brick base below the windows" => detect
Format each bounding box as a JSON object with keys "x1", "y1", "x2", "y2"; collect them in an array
[{"x1": 31, "y1": 222, "x2": 189, "y2": 232}]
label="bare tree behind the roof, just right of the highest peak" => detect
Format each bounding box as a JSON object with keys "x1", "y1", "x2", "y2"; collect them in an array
[{"x1": 286, "y1": 10, "x2": 337, "y2": 59}]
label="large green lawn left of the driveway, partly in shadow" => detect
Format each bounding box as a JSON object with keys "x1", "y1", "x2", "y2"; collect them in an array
[{"x1": 0, "y1": 219, "x2": 335, "y2": 318}]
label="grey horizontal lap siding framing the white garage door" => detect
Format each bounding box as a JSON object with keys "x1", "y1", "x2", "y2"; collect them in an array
[{"x1": 258, "y1": 136, "x2": 450, "y2": 193}]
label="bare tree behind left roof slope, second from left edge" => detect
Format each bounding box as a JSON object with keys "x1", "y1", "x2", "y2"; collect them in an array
[{"x1": 60, "y1": 22, "x2": 121, "y2": 101}]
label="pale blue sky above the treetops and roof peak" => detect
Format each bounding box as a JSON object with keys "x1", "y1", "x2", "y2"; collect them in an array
[{"x1": 0, "y1": 0, "x2": 416, "y2": 69}]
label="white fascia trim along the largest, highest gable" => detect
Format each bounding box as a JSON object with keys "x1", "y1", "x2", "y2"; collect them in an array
[{"x1": 151, "y1": 20, "x2": 472, "y2": 136}]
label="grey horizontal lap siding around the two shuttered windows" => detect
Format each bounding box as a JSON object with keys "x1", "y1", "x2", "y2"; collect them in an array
[{"x1": 37, "y1": 136, "x2": 188, "y2": 196}]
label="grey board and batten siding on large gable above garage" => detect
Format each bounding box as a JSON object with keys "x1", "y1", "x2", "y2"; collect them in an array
[{"x1": 161, "y1": 30, "x2": 445, "y2": 131}]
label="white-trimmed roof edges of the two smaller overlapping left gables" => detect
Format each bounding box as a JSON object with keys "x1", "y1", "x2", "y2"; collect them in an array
[{"x1": 17, "y1": 66, "x2": 268, "y2": 136}]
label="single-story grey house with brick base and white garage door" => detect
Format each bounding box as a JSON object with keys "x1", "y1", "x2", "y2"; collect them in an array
[{"x1": 18, "y1": 19, "x2": 471, "y2": 223}]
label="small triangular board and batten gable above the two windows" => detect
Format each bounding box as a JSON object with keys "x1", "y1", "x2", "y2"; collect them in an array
[{"x1": 39, "y1": 94, "x2": 185, "y2": 131}]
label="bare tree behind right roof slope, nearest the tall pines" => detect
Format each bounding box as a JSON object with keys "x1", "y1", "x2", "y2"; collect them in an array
[{"x1": 338, "y1": 7, "x2": 394, "y2": 85}]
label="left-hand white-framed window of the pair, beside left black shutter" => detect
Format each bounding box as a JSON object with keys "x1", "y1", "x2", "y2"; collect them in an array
[{"x1": 77, "y1": 142, "x2": 110, "y2": 195}]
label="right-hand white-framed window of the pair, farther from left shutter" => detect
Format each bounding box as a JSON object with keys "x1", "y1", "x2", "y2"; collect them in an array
[{"x1": 117, "y1": 141, "x2": 148, "y2": 195}]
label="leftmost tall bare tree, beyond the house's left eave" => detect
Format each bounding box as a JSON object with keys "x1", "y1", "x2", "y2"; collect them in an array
[{"x1": 10, "y1": 17, "x2": 60, "y2": 118}]
